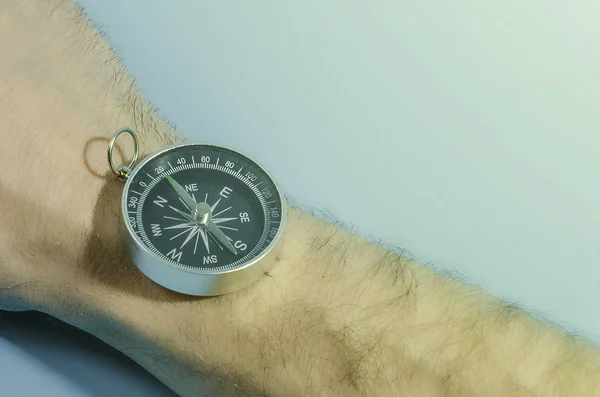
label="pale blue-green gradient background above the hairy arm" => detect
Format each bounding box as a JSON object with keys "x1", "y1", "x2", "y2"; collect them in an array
[{"x1": 0, "y1": 0, "x2": 600, "y2": 395}]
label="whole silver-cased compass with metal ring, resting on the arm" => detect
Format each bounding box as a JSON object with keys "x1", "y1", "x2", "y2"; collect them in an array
[{"x1": 109, "y1": 129, "x2": 286, "y2": 296}]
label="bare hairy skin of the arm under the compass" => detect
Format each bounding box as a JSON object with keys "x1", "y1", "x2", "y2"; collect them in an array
[{"x1": 0, "y1": 0, "x2": 600, "y2": 396}]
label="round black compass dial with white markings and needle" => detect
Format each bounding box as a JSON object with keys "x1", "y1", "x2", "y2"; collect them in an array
[{"x1": 123, "y1": 144, "x2": 283, "y2": 271}]
